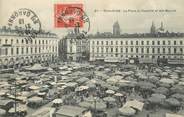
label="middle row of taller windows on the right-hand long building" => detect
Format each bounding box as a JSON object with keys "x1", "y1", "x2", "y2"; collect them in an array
[{"x1": 92, "y1": 47, "x2": 183, "y2": 54}]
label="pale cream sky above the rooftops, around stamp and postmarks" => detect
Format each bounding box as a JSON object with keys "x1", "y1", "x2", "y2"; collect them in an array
[{"x1": 0, "y1": 0, "x2": 184, "y2": 36}]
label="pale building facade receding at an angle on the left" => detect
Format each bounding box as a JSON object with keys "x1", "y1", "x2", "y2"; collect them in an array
[{"x1": 0, "y1": 30, "x2": 59, "y2": 68}]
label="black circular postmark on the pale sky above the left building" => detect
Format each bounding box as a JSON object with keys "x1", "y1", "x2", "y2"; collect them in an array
[{"x1": 8, "y1": 8, "x2": 41, "y2": 40}]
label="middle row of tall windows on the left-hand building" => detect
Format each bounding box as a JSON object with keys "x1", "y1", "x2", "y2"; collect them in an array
[{"x1": 0, "y1": 46, "x2": 57, "y2": 55}]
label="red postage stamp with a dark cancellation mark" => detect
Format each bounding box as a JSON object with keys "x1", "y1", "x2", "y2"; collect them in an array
[{"x1": 54, "y1": 4, "x2": 84, "y2": 28}]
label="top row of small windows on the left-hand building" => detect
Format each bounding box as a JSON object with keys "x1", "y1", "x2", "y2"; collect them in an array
[{"x1": 0, "y1": 39, "x2": 57, "y2": 44}]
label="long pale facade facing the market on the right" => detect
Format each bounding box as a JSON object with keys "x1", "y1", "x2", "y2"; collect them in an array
[{"x1": 90, "y1": 37, "x2": 184, "y2": 62}]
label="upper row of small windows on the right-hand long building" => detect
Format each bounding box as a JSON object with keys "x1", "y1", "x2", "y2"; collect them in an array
[{"x1": 92, "y1": 40, "x2": 183, "y2": 45}]
